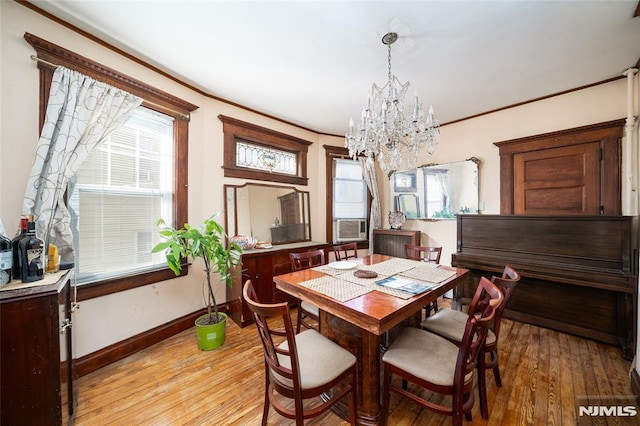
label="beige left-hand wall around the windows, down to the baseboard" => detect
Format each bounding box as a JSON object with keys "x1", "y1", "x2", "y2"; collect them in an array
[{"x1": 0, "y1": 1, "x2": 343, "y2": 357}]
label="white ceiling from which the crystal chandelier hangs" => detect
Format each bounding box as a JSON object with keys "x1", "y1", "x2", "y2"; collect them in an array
[{"x1": 32, "y1": 0, "x2": 640, "y2": 134}]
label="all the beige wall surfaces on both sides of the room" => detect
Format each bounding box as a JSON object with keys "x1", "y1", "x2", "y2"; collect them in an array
[{"x1": 0, "y1": 2, "x2": 640, "y2": 357}]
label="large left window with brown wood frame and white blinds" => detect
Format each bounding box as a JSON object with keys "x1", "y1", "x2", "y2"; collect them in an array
[{"x1": 24, "y1": 33, "x2": 198, "y2": 301}]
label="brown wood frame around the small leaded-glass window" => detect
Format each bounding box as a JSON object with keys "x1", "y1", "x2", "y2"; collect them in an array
[{"x1": 218, "y1": 115, "x2": 311, "y2": 186}]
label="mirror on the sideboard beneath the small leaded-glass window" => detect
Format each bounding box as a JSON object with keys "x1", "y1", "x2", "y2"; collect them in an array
[{"x1": 224, "y1": 183, "x2": 311, "y2": 244}]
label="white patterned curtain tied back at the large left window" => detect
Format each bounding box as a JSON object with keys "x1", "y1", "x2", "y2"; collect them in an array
[{"x1": 22, "y1": 67, "x2": 142, "y2": 263}]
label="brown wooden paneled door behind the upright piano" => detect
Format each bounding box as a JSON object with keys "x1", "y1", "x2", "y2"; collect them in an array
[{"x1": 513, "y1": 142, "x2": 600, "y2": 215}]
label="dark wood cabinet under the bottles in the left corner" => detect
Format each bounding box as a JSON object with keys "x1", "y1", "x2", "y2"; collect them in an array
[{"x1": 0, "y1": 271, "x2": 74, "y2": 425}]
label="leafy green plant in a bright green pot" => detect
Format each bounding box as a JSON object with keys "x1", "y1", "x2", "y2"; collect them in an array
[{"x1": 152, "y1": 212, "x2": 242, "y2": 350}]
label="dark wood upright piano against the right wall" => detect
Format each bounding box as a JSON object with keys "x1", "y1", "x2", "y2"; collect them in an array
[{"x1": 451, "y1": 215, "x2": 638, "y2": 359}]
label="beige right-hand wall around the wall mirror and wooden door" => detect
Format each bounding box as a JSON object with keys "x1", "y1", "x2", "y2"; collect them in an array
[{"x1": 379, "y1": 80, "x2": 626, "y2": 265}]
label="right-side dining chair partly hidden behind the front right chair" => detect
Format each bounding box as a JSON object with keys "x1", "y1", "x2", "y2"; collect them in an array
[{"x1": 420, "y1": 265, "x2": 520, "y2": 419}]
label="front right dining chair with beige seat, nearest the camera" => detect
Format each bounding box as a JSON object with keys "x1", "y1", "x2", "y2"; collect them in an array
[{"x1": 382, "y1": 277, "x2": 504, "y2": 426}]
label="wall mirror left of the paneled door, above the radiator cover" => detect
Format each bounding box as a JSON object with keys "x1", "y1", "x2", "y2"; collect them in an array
[{"x1": 389, "y1": 157, "x2": 480, "y2": 220}]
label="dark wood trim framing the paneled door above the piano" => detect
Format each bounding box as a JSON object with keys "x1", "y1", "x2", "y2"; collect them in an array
[{"x1": 494, "y1": 119, "x2": 625, "y2": 216}]
